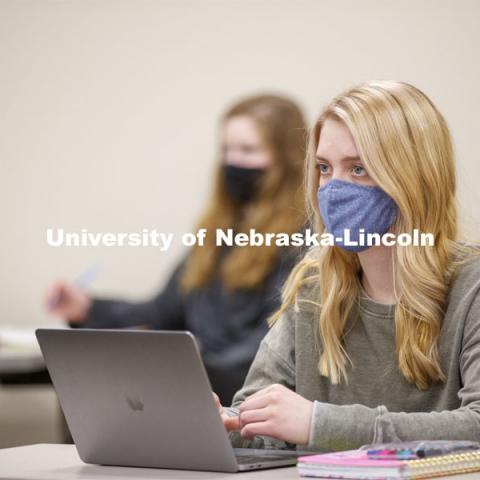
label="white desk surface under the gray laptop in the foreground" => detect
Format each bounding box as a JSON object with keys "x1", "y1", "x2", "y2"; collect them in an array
[{"x1": 0, "y1": 444, "x2": 480, "y2": 480}]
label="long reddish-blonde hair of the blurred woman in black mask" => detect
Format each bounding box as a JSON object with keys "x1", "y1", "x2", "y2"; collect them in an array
[{"x1": 181, "y1": 95, "x2": 307, "y2": 292}]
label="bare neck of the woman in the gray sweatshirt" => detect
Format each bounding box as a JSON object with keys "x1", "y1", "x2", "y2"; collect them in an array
[{"x1": 358, "y1": 245, "x2": 397, "y2": 305}]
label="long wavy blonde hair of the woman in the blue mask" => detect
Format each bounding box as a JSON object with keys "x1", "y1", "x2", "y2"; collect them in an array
[{"x1": 271, "y1": 82, "x2": 472, "y2": 390}]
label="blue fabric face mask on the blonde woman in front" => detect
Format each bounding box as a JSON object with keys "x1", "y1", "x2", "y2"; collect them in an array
[{"x1": 317, "y1": 180, "x2": 398, "y2": 252}]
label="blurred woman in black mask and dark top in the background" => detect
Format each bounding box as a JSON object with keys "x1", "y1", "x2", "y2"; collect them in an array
[{"x1": 46, "y1": 95, "x2": 306, "y2": 402}]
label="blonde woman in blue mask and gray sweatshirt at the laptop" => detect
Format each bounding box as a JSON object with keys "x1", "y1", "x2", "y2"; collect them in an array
[{"x1": 217, "y1": 82, "x2": 480, "y2": 450}]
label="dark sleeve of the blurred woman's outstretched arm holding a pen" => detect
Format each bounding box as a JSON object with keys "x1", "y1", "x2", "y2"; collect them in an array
[{"x1": 81, "y1": 262, "x2": 185, "y2": 330}]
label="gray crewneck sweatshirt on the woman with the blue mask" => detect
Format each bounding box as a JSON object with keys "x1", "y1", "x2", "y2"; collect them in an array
[{"x1": 230, "y1": 253, "x2": 480, "y2": 450}]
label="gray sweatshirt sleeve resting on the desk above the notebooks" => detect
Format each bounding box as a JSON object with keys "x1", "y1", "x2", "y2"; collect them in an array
[{"x1": 308, "y1": 291, "x2": 480, "y2": 449}]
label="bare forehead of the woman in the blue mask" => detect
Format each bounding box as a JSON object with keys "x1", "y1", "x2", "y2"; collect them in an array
[{"x1": 317, "y1": 118, "x2": 358, "y2": 160}]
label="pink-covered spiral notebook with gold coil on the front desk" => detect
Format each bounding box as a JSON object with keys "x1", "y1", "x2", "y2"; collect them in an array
[{"x1": 297, "y1": 450, "x2": 480, "y2": 480}]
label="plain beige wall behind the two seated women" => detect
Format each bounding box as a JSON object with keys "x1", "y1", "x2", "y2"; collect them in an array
[{"x1": 0, "y1": 0, "x2": 480, "y2": 324}]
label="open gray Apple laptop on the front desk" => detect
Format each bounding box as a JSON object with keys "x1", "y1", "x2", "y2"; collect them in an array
[{"x1": 36, "y1": 329, "x2": 313, "y2": 472}]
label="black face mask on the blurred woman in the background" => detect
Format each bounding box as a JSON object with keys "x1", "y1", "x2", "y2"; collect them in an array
[{"x1": 223, "y1": 165, "x2": 265, "y2": 204}]
